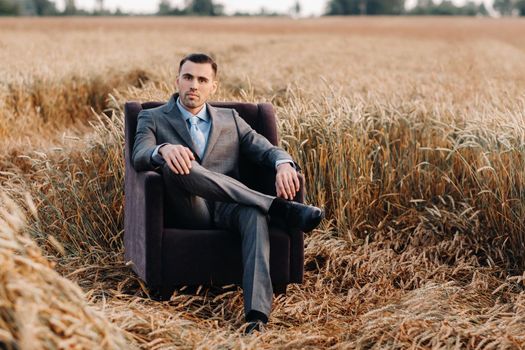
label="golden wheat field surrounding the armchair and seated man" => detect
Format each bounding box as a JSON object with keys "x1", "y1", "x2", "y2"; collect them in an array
[{"x1": 0, "y1": 17, "x2": 525, "y2": 349}]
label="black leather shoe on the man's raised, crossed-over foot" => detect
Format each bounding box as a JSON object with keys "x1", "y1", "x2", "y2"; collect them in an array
[{"x1": 268, "y1": 198, "x2": 324, "y2": 232}]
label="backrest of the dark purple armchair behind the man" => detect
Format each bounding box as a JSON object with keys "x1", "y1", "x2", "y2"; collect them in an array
[{"x1": 124, "y1": 102, "x2": 279, "y2": 195}]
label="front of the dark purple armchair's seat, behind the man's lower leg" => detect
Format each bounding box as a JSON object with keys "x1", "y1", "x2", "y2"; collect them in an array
[{"x1": 161, "y1": 226, "x2": 290, "y2": 285}]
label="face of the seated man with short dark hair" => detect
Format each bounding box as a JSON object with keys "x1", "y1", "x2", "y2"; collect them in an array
[{"x1": 177, "y1": 61, "x2": 217, "y2": 114}]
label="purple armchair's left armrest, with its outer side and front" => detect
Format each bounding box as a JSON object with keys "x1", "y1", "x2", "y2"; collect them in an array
[{"x1": 124, "y1": 167, "x2": 164, "y2": 286}]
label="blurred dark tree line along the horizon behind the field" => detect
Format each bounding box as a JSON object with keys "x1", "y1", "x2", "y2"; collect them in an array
[{"x1": 0, "y1": 0, "x2": 525, "y2": 16}]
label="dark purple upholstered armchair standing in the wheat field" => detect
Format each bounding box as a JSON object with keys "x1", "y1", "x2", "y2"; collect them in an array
[{"x1": 124, "y1": 102, "x2": 304, "y2": 300}]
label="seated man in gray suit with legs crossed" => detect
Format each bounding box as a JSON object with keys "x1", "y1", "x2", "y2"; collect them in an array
[{"x1": 132, "y1": 54, "x2": 323, "y2": 332}]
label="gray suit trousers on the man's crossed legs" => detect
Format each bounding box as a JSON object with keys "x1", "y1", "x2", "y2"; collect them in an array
[{"x1": 162, "y1": 161, "x2": 275, "y2": 316}]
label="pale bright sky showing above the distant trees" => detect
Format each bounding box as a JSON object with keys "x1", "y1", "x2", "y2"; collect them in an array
[{"x1": 55, "y1": 0, "x2": 492, "y2": 16}]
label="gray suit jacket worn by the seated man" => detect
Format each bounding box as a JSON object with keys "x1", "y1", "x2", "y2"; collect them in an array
[{"x1": 132, "y1": 94, "x2": 293, "y2": 179}]
